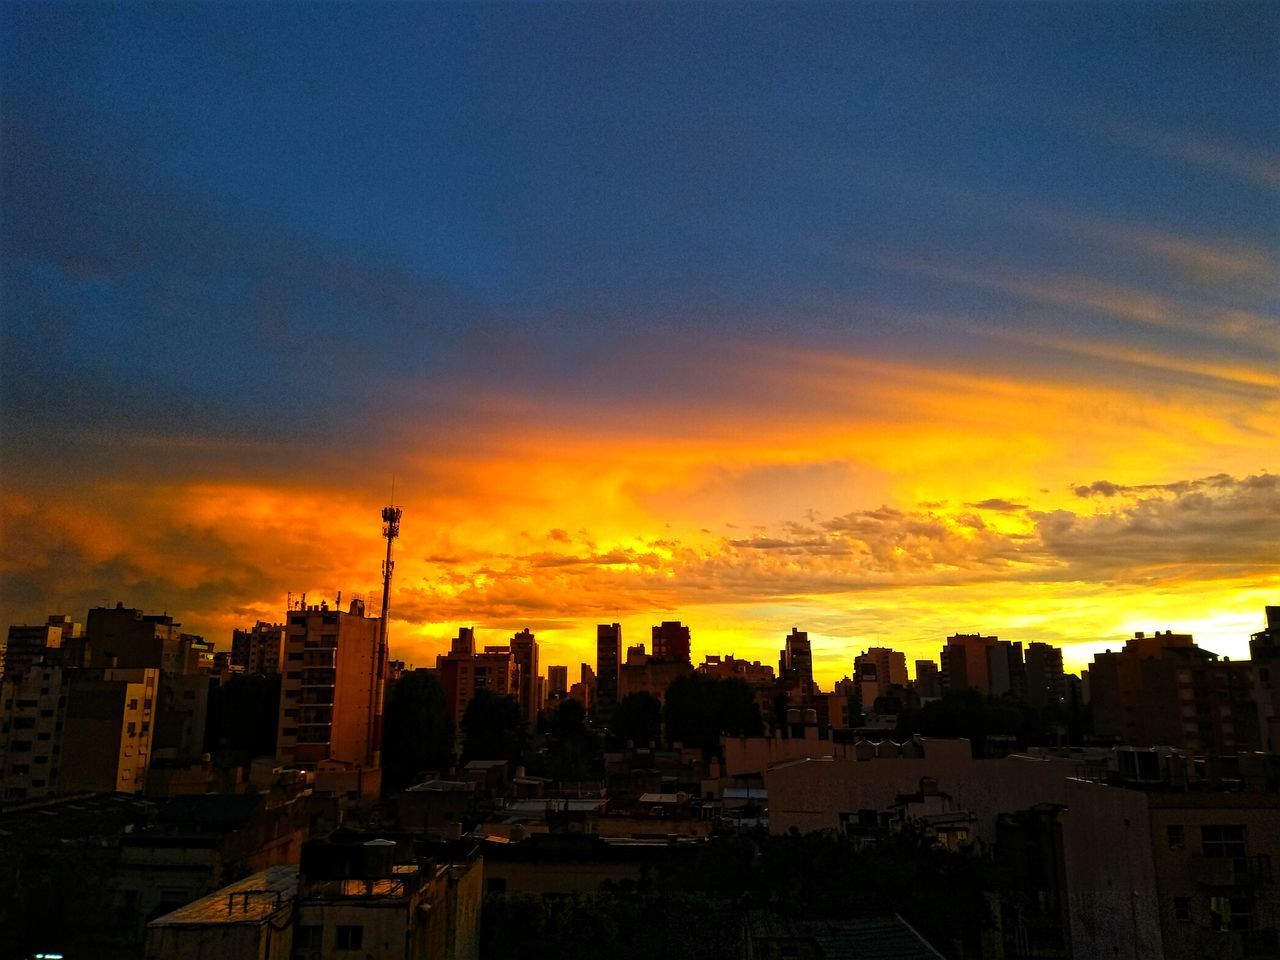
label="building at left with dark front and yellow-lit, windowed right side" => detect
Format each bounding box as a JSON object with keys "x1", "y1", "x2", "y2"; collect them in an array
[{"x1": 58, "y1": 667, "x2": 161, "y2": 794}]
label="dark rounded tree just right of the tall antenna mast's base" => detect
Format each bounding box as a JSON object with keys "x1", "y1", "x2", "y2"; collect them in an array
[{"x1": 383, "y1": 671, "x2": 453, "y2": 795}]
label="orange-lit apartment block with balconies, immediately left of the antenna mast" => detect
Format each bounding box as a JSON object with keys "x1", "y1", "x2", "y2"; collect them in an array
[{"x1": 276, "y1": 600, "x2": 385, "y2": 767}]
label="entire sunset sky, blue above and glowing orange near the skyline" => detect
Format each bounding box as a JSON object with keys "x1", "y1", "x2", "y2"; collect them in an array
[{"x1": 0, "y1": 3, "x2": 1280, "y2": 685}]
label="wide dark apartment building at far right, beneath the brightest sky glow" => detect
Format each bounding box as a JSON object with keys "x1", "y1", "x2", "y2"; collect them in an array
[{"x1": 1089, "y1": 631, "x2": 1261, "y2": 754}]
